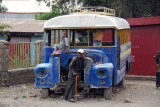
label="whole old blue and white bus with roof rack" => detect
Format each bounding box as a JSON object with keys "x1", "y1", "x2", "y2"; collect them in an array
[{"x1": 35, "y1": 7, "x2": 131, "y2": 100}]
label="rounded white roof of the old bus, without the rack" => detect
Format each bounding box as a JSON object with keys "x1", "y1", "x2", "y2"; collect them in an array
[{"x1": 44, "y1": 14, "x2": 130, "y2": 29}]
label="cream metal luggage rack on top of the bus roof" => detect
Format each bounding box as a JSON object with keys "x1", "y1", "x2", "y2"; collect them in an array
[{"x1": 69, "y1": 6, "x2": 115, "y2": 16}]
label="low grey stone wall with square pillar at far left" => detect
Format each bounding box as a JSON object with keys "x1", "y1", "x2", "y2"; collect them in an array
[{"x1": 0, "y1": 40, "x2": 35, "y2": 87}]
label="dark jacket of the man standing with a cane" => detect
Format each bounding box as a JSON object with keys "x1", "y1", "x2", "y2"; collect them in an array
[{"x1": 68, "y1": 56, "x2": 86, "y2": 78}]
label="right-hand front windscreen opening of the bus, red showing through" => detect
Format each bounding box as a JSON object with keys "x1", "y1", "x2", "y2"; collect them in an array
[{"x1": 70, "y1": 29, "x2": 116, "y2": 46}]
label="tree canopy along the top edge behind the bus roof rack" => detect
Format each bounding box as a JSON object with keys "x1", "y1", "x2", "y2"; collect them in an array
[{"x1": 37, "y1": 0, "x2": 160, "y2": 18}]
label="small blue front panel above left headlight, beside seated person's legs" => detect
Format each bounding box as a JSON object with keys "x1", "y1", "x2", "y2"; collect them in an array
[{"x1": 44, "y1": 47, "x2": 53, "y2": 63}]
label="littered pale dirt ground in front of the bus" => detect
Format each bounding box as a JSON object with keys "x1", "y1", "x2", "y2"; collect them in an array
[{"x1": 0, "y1": 80, "x2": 160, "y2": 107}]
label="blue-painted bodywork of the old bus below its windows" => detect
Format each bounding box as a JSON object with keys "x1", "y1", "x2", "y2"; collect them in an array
[{"x1": 35, "y1": 45, "x2": 131, "y2": 88}]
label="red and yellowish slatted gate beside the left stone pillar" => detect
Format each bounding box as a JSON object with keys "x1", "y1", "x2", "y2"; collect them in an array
[{"x1": 8, "y1": 43, "x2": 30, "y2": 69}]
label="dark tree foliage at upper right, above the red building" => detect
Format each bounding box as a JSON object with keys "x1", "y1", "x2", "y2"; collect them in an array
[{"x1": 83, "y1": 0, "x2": 160, "y2": 18}]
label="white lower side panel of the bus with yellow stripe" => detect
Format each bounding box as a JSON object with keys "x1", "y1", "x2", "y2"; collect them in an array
[{"x1": 118, "y1": 42, "x2": 131, "y2": 83}]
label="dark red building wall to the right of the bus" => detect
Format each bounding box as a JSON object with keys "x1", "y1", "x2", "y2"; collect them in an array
[{"x1": 126, "y1": 16, "x2": 160, "y2": 76}]
